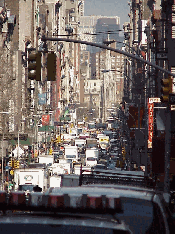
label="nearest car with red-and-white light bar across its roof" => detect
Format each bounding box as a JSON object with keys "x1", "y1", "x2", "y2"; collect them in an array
[{"x1": 0, "y1": 187, "x2": 133, "y2": 234}]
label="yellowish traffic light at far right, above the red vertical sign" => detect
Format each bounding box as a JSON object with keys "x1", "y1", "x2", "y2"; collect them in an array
[{"x1": 160, "y1": 76, "x2": 172, "y2": 102}]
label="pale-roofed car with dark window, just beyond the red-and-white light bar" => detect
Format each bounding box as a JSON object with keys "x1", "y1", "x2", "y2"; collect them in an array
[{"x1": 43, "y1": 184, "x2": 174, "y2": 234}]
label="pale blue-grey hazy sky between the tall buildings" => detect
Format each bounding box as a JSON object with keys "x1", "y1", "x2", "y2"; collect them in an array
[{"x1": 84, "y1": 0, "x2": 129, "y2": 29}]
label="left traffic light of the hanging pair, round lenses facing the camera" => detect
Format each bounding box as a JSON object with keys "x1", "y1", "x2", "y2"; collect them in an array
[{"x1": 28, "y1": 52, "x2": 41, "y2": 81}]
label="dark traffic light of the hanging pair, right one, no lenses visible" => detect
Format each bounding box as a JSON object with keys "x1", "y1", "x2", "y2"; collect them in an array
[{"x1": 47, "y1": 52, "x2": 56, "y2": 81}]
